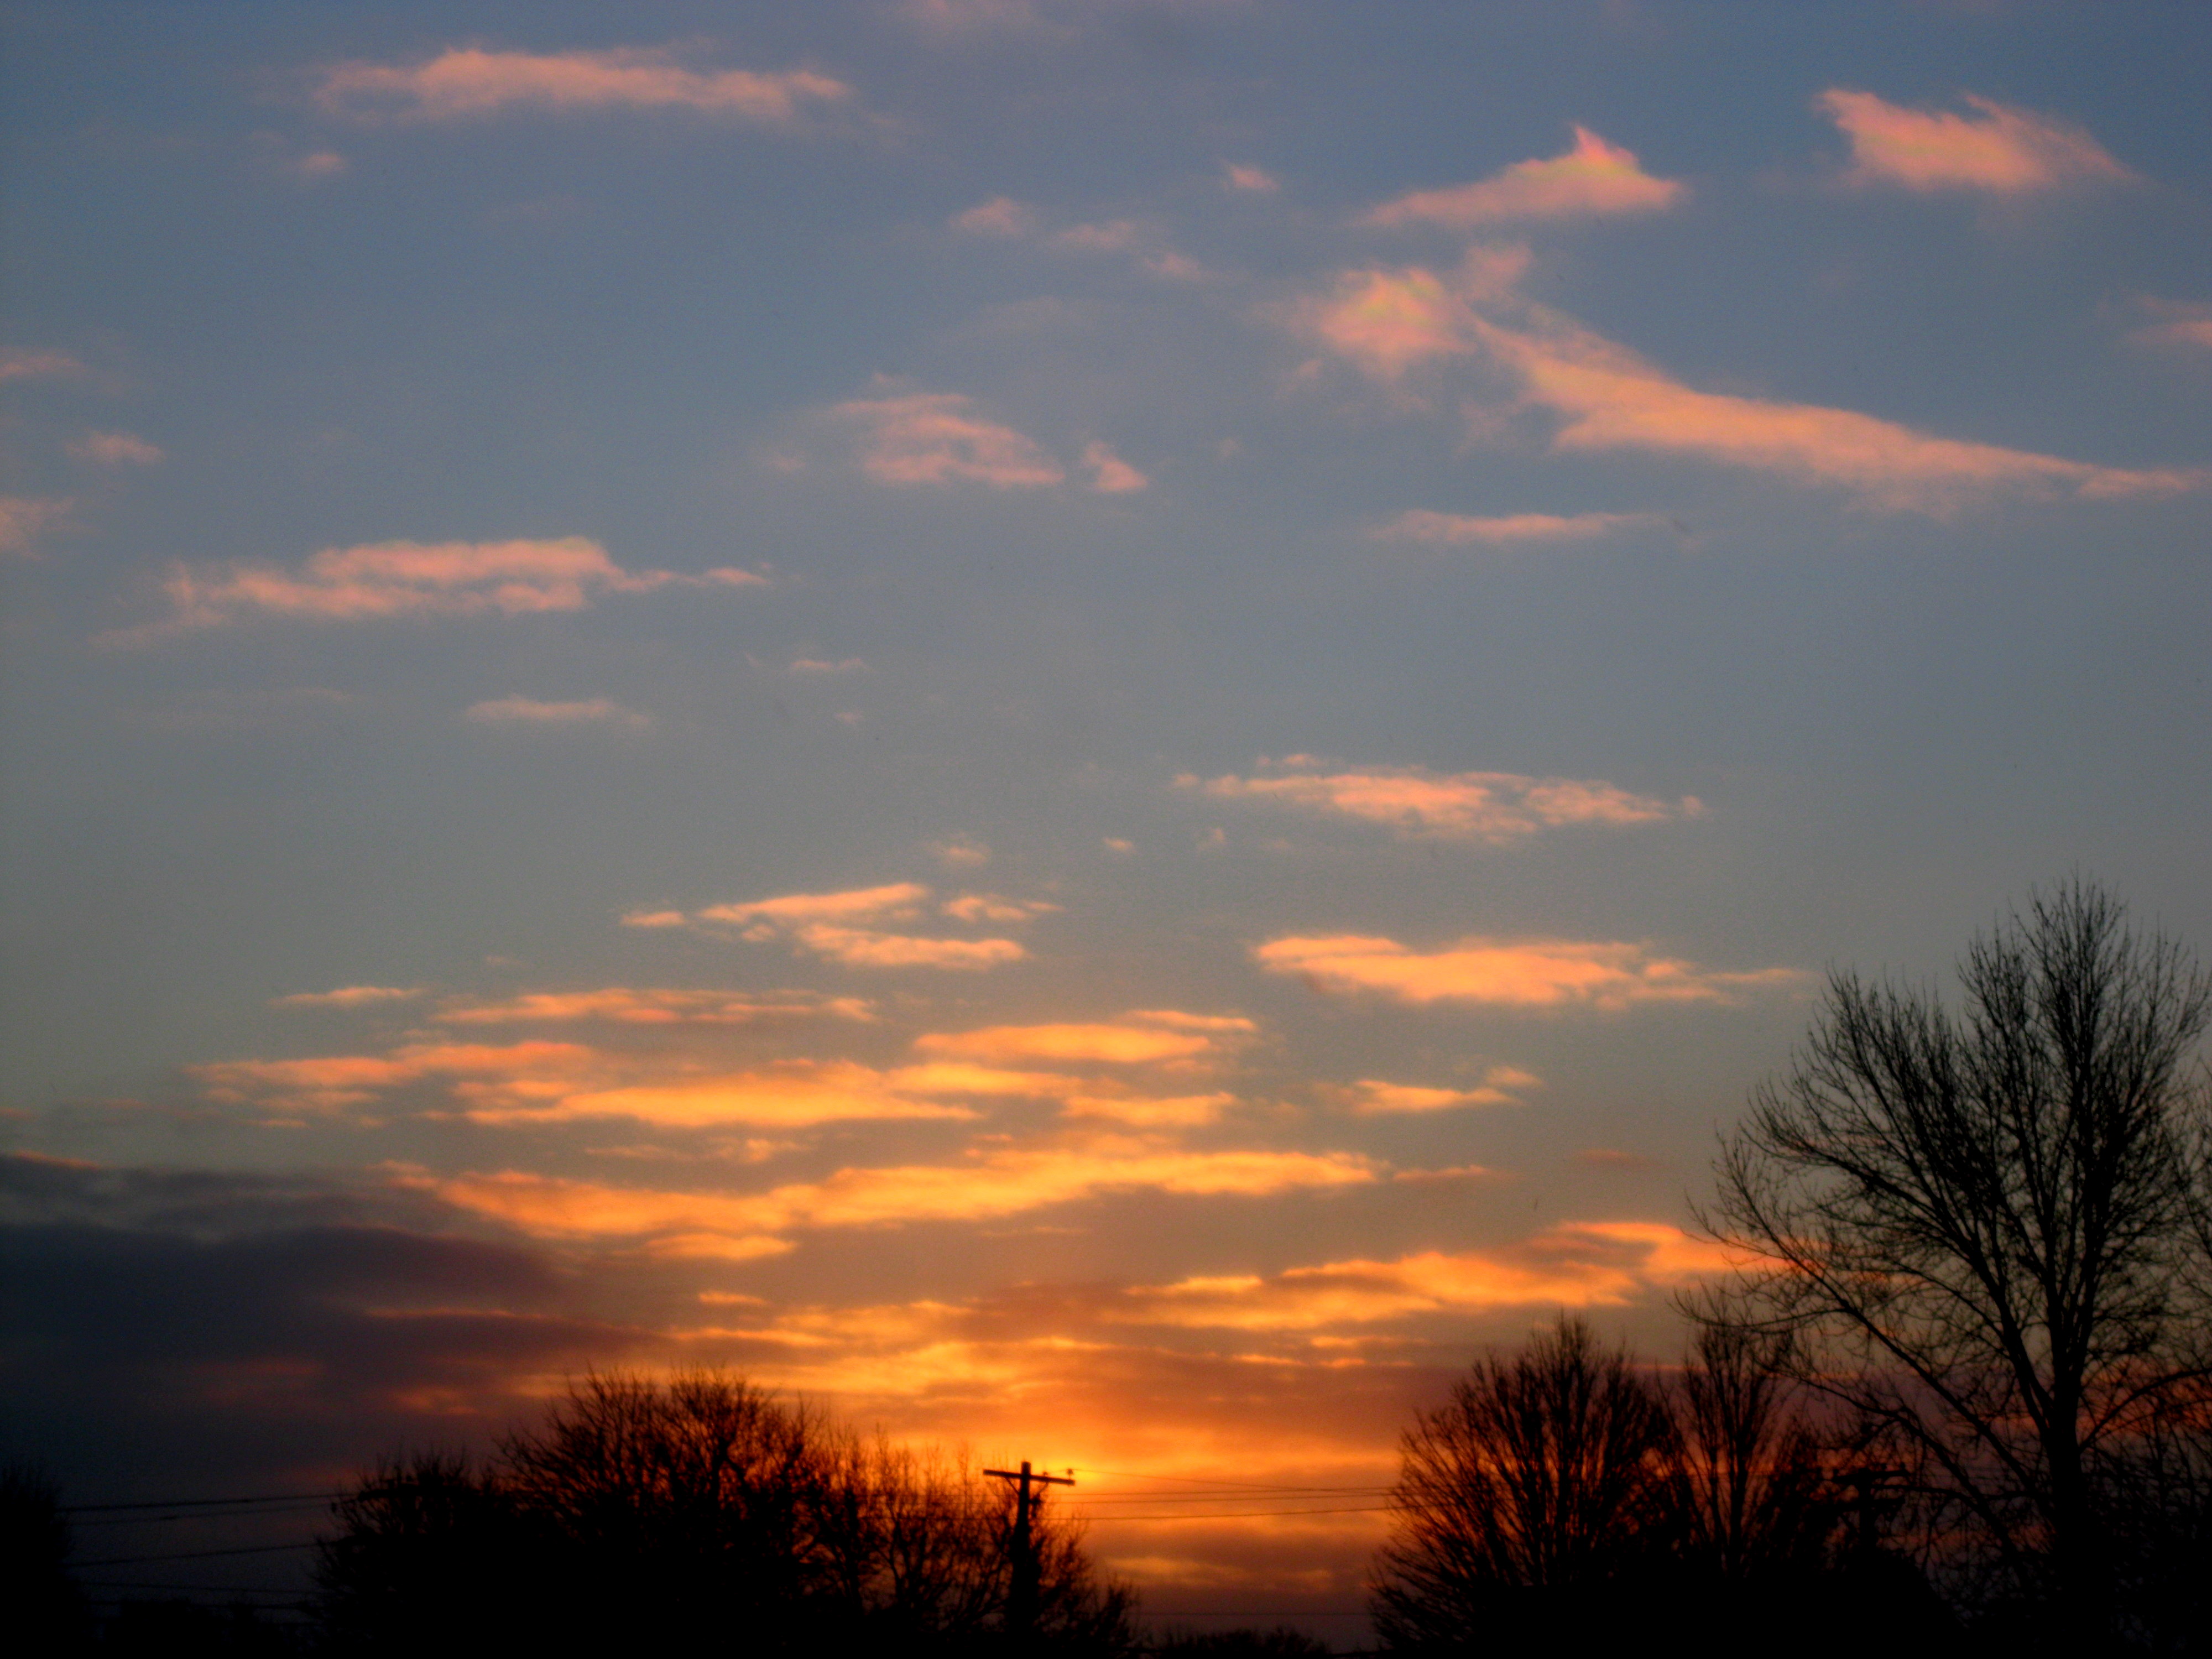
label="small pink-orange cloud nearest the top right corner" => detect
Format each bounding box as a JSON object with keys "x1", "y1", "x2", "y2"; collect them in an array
[{"x1": 1814, "y1": 86, "x2": 2135, "y2": 195}]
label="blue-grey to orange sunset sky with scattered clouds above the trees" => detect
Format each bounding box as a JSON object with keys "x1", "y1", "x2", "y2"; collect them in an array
[{"x1": 0, "y1": 0, "x2": 2212, "y2": 1637}]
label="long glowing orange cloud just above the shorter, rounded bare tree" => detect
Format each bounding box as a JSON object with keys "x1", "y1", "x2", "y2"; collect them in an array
[{"x1": 1108, "y1": 1221, "x2": 1730, "y2": 1332}]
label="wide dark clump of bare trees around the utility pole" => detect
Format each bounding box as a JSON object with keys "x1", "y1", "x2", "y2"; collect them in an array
[{"x1": 321, "y1": 1371, "x2": 1133, "y2": 1659}]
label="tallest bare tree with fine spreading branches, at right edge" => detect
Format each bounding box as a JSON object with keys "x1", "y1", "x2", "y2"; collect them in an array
[{"x1": 1705, "y1": 880, "x2": 2212, "y2": 1644}]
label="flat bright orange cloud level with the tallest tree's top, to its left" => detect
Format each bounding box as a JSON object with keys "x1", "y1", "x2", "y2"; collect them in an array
[{"x1": 1252, "y1": 933, "x2": 1803, "y2": 1009}]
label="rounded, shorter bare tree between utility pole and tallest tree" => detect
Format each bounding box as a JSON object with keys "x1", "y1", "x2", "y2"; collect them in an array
[{"x1": 1371, "y1": 1316, "x2": 1672, "y2": 1648}]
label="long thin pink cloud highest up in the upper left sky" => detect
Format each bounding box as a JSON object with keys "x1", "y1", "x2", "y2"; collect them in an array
[{"x1": 316, "y1": 46, "x2": 852, "y2": 126}]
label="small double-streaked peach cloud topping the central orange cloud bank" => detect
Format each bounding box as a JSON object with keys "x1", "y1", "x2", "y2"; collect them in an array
[{"x1": 650, "y1": 880, "x2": 1040, "y2": 971}]
